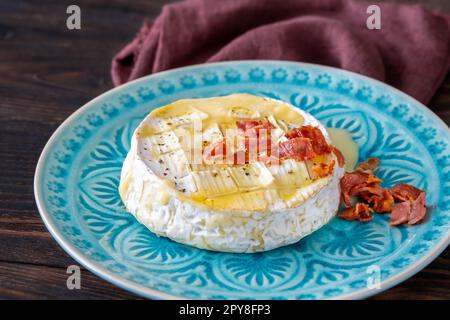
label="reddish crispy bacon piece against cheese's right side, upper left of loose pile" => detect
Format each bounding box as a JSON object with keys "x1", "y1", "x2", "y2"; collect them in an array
[{"x1": 341, "y1": 172, "x2": 381, "y2": 207}]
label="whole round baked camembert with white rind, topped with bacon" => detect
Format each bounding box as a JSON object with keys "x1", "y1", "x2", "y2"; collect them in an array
[{"x1": 119, "y1": 94, "x2": 344, "y2": 252}]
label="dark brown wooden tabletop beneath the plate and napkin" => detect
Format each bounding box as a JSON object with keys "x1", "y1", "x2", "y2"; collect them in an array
[{"x1": 0, "y1": 0, "x2": 450, "y2": 299}]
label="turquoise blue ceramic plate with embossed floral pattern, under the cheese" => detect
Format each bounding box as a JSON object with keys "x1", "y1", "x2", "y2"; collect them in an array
[{"x1": 34, "y1": 61, "x2": 450, "y2": 299}]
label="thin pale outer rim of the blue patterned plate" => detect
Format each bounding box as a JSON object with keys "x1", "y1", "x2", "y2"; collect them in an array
[{"x1": 33, "y1": 59, "x2": 450, "y2": 300}]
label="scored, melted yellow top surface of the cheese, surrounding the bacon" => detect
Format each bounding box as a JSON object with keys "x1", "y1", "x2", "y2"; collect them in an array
[{"x1": 126, "y1": 94, "x2": 352, "y2": 211}]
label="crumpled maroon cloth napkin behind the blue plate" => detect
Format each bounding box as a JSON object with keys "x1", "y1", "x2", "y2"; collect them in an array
[{"x1": 111, "y1": 0, "x2": 450, "y2": 103}]
